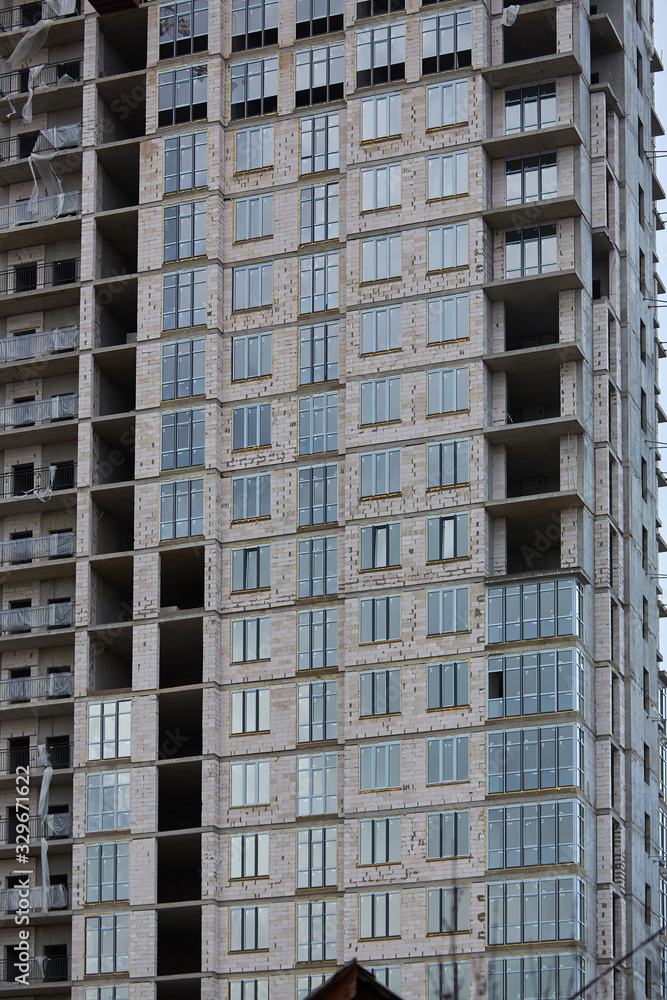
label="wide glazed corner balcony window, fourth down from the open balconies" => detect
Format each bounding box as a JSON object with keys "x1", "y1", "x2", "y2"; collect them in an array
[{"x1": 486, "y1": 799, "x2": 585, "y2": 868}]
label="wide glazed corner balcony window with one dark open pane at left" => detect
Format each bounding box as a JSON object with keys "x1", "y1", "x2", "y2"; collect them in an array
[{"x1": 486, "y1": 649, "x2": 584, "y2": 719}]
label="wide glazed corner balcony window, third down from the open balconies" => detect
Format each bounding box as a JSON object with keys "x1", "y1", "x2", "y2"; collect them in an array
[{"x1": 487, "y1": 725, "x2": 584, "y2": 794}]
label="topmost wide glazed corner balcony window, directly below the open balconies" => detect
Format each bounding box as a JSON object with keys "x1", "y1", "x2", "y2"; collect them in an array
[{"x1": 486, "y1": 579, "x2": 584, "y2": 643}]
